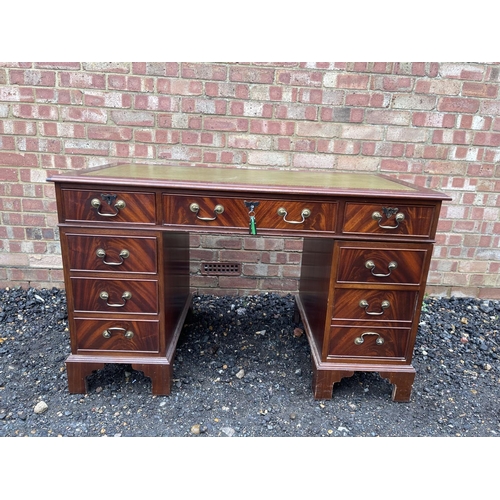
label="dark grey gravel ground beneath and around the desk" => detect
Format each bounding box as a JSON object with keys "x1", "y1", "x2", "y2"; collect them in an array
[{"x1": 0, "y1": 288, "x2": 500, "y2": 438}]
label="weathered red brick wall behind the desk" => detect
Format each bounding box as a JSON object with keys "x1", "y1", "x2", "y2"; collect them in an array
[{"x1": 0, "y1": 62, "x2": 500, "y2": 299}]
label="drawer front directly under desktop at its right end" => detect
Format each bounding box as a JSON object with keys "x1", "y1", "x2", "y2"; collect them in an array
[{"x1": 343, "y1": 202, "x2": 436, "y2": 238}]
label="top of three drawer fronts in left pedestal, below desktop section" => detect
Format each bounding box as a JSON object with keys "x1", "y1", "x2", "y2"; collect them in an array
[{"x1": 62, "y1": 234, "x2": 157, "y2": 273}]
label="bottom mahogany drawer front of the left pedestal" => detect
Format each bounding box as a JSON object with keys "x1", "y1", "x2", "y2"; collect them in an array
[{"x1": 75, "y1": 319, "x2": 160, "y2": 353}]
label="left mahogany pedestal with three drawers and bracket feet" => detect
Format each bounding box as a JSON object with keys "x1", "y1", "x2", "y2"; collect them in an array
[{"x1": 60, "y1": 225, "x2": 191, "y2": 395}]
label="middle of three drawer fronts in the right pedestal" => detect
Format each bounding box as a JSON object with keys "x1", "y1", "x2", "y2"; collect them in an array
[{"x1": 332, "y1": 288, "x2": 418, "y2": 322}]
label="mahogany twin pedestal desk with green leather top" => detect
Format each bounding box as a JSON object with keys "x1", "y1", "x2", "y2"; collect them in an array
[{"x1": 48, "y1": 164, "x2": 449, "y2": 401}]
